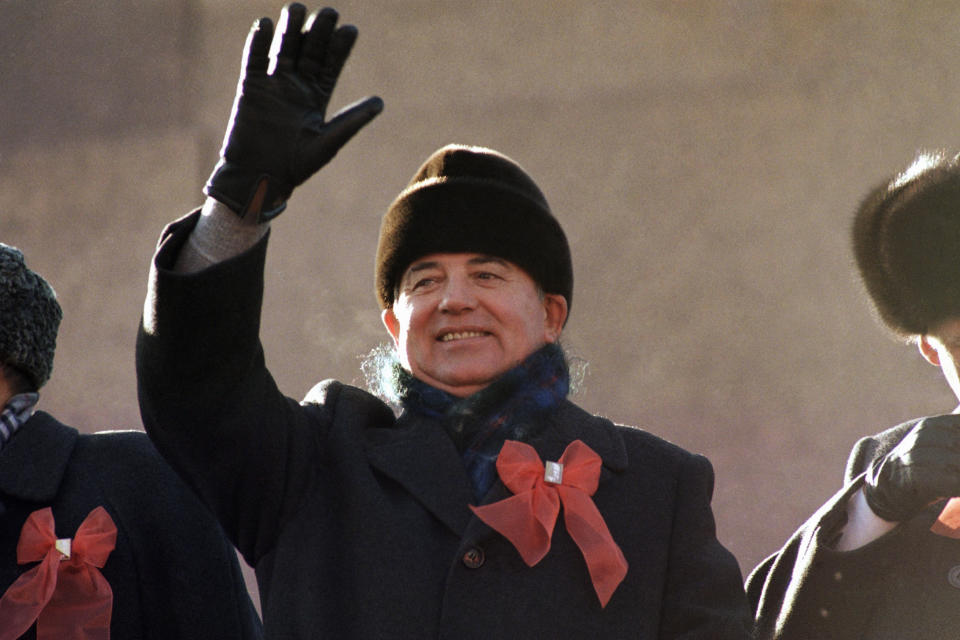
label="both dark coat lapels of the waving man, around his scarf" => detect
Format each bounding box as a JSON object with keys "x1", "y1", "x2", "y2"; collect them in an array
[{"x1": 367, "y1": 401, "x2": 627, "y2": 536}]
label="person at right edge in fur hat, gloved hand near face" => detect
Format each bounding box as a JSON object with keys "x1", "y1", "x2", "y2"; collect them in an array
[{"x1": 747, "y1": 152, "x2": 960, "y2": 639}]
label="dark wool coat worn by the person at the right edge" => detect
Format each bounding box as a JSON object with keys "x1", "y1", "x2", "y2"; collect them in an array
[{"x1": 747, "y1": 420, "x2": 960, "y2": 640}]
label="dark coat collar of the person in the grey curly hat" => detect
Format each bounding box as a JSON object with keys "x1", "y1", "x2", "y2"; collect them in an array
[{"x1": 0, "y1": 411, "x2": 78, "y2": 502}]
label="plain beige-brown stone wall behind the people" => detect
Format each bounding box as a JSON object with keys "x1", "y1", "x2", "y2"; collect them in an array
[{"x1": 0, "y1": 0, "x2": 960, "y2": 608}]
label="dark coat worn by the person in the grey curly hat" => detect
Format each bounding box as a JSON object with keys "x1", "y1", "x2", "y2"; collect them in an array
[{"x1": 0, "y1": 411, "x2": 262, "y2": 640}]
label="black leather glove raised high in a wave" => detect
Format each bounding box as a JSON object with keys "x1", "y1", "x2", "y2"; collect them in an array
[{"x1": 203, "y1": 3, "x2": 383, "y2": 221}]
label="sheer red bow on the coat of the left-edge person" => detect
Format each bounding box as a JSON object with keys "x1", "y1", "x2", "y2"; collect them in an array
[{"x1": 0, "y1": 507, "x2": 117, "y2": 640}]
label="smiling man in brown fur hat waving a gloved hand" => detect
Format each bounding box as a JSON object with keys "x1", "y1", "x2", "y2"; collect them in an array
[{"x1": 137, "y1": 4, "x2": 749, "y2": 640}]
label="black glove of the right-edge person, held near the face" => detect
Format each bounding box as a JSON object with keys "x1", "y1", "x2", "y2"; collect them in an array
[{"x1": 864, "y1": 414, "x2": 960, "y2": 522}]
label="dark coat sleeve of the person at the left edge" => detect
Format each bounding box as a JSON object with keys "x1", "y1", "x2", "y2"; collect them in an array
[{"x1": 80, "y1": 432, "x2": 262, "y2": 640}]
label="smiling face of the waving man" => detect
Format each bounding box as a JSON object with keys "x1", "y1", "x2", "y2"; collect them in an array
[{"x1": 382, "y1": 253, "x2": 567, "y2": 397}]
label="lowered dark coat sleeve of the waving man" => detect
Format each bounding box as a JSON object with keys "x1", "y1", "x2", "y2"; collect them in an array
[{"x1": 660, "y1": 455, "x2": 750, "y2": 640}]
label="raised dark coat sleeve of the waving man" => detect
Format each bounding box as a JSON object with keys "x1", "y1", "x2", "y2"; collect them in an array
[{"x1": 136, "y1": 212, "x2": 326, "y2": 564}]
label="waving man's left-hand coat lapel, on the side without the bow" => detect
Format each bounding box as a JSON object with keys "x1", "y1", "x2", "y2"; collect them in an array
[{"x1": 367, "y1": 413, "x2": 474, "y2": 535}]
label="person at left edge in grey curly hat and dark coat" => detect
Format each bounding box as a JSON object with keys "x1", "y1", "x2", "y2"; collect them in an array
[{"x1": 0, "y1": 243, "x2": 262, "y2": 640}]
